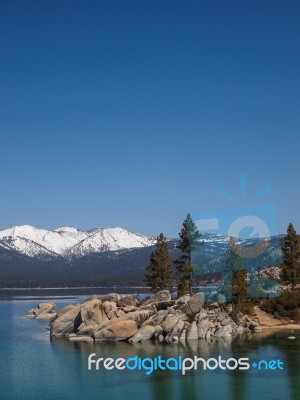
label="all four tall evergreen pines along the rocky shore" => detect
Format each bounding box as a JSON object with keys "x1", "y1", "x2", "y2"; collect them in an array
[{"x1": 144, "y1": 214, "x2": 300, "y2": 314}]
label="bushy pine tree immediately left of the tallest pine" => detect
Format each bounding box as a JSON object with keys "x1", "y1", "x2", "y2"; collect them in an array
[{"x1": 144, "y1": 233, "x2": 173, "y2": 293}]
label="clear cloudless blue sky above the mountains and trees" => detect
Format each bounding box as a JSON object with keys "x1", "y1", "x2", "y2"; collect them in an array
[{"x1": 0, "y1": 0, "x2": 300, "y2": 236}]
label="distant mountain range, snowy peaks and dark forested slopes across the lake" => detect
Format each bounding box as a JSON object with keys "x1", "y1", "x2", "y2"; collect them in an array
[{"x1": 0, "y1": 225, "x2": 281, "y2": 288}]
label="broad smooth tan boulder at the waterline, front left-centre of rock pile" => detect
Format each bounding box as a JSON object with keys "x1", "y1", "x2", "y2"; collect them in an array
[{"x1": 93, "y1": 320, "x2": 138, "y2": 342}]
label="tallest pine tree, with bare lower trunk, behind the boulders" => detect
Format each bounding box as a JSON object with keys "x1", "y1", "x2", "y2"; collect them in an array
[{"x1": 175, "y1": 214, "x2": 202, "y2": 296}]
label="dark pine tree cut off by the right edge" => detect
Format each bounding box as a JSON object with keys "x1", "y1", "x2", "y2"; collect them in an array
[{"x1": 282, "y1": 224, "x2": 300, "y2": 289}]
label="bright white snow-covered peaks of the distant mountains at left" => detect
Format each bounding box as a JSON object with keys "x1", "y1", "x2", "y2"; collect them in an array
[{"x1": 0, "y1": 225, "x2": 155, "y2": 260}]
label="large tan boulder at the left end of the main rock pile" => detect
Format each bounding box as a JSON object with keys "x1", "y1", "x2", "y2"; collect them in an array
[{"x1": 50, "y1": 305, "x2": 82, "y2": 336}]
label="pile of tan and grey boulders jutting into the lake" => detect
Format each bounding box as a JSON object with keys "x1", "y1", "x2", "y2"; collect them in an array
[{"x1": 26, "y1": 290, "x2": 261, "y2": 343}]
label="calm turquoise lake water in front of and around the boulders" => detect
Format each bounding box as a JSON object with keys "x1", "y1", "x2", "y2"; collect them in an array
[{"x1": 0, "y1": 298, "x2": 300, "y2": 400}]
